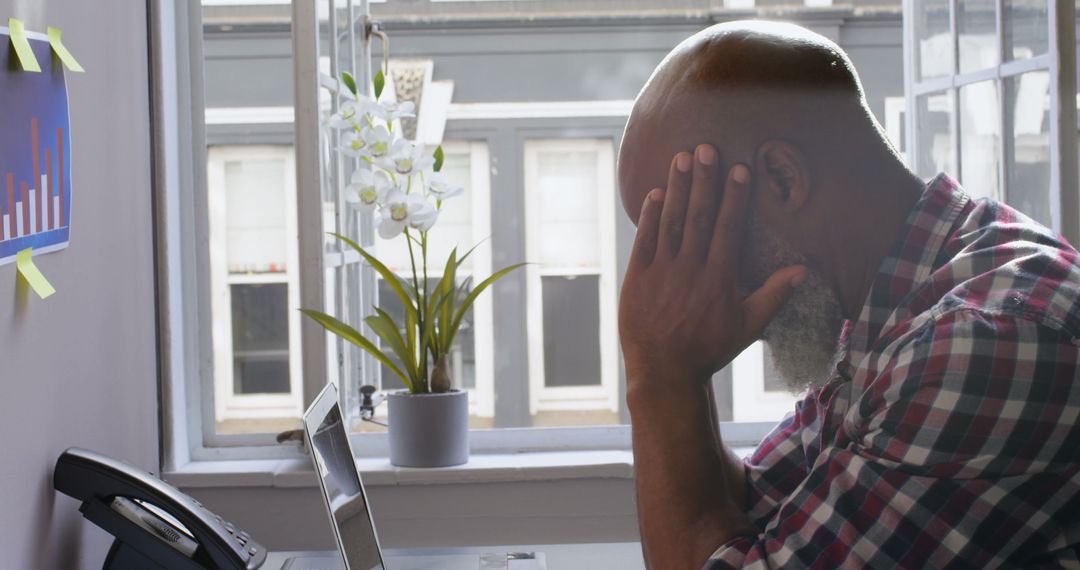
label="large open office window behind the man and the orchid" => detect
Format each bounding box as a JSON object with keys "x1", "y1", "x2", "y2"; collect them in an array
[{"x1": 168, "y1": 0, "x2": 1080, "y2": 458}]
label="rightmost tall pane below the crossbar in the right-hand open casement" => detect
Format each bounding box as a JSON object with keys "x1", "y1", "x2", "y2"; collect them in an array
[{"x1": 1004, "y1": 71, "x2": 1053, "y2": 227}]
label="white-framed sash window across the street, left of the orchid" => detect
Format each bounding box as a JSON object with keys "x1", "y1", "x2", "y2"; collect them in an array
[{"x1": 207, "y1": 146, "x2": 301, "y2": 433}]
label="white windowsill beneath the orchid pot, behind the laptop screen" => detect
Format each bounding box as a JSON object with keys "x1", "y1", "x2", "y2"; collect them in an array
[{"x1": 164, "y1": 448, "x2": 753, "y2": 488}]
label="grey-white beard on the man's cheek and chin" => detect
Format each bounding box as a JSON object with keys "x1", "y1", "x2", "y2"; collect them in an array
[{"x1": 737, "y1": 215, "x2": 843, "y2": 393}]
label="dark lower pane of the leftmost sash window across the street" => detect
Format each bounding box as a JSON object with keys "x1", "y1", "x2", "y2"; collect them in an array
[{"x1": 230, "y1": 283, "x2": 289, "y2": 394}]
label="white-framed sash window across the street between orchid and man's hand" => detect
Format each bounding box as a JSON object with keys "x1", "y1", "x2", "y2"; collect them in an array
[{"x1": 525, "y1": 139, "x2": 619, "y2": 425}]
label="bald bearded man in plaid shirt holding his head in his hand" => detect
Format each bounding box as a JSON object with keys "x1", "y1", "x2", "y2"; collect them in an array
[{"x1": 619, "y1": 22, "x2": 1080, "y2": 570}]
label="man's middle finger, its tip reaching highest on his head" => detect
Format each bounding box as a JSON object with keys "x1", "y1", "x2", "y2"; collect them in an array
[{"x1": 679, "y1": 145, "x2": 720, "y2": 261}]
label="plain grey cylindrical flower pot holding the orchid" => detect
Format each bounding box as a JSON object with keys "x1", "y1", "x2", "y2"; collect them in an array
[{"x1": 388, "y1": 390, "x2": 469, "y2": 467}]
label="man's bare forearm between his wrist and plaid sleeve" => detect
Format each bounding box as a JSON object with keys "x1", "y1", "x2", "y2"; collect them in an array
[{"x1": 627, "y1": 375, "x2": 754, "y2": 570}]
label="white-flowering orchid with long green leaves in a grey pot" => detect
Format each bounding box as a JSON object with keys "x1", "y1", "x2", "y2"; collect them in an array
[{"x1": 301, "y1": 71, "x2": 523, "y2": 466}]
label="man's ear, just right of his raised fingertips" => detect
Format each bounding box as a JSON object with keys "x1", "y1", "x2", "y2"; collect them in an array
[{"x1": 754, "y1": 138, "x2": 811, "y2": 214}]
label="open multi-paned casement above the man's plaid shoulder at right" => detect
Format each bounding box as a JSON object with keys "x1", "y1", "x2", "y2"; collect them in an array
[{"x1": 905, "y1": 0, "x2": 1077, "y2": 234}]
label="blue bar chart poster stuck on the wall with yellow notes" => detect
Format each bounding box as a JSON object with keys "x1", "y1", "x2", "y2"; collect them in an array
[{"x1": 0, "y1": 27, "x2": 71, "y2": 264}]
